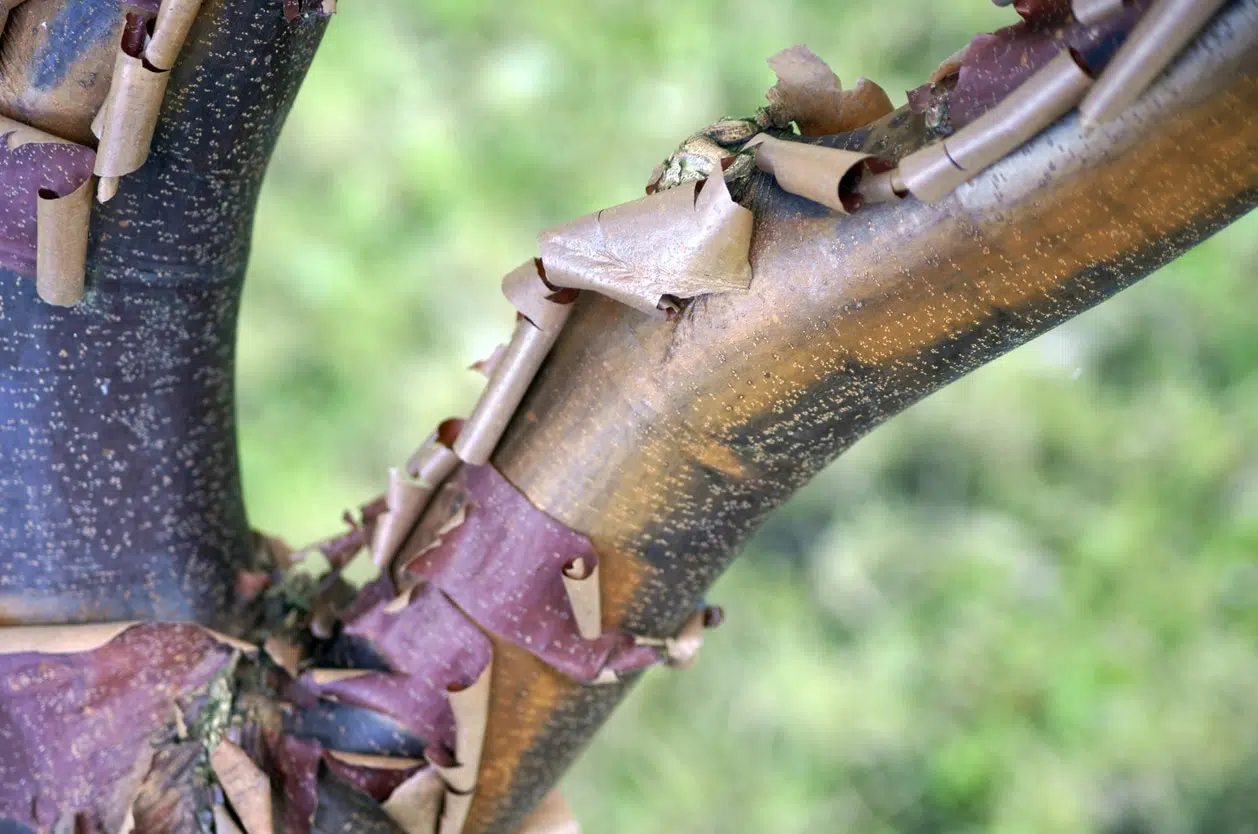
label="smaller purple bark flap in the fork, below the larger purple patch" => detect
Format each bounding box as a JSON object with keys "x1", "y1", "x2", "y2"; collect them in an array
[{"x1": 301, "y1": 580, "x2": 493, "y2": 755}]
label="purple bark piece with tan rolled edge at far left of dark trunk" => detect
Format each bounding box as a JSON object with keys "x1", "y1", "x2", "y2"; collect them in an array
[{"x1": 0, "y1": 116, "x2": 96, "y2": 306}]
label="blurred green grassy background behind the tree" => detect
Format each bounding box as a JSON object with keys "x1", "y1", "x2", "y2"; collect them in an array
[{"x1": 239, "y1": 0, "x2": 1258, "y2": 834}]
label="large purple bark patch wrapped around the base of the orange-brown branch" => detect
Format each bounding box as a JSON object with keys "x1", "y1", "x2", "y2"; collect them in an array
[{"x1": 400, "y1": 467, "x2": 660, "y2": 682}]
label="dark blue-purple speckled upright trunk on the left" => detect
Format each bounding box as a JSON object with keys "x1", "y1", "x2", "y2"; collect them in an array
[{"x1": 0, "y1": 0, "x2": 323, "y2": 626}]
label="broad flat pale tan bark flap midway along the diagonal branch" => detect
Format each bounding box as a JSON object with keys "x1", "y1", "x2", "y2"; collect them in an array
[{"x1": 538, "y1": 176, "x2": 752, "y2": 316}]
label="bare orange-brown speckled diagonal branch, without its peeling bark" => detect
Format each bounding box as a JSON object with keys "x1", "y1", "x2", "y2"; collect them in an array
[{"x1": 405, "y1": 0, "x2": 1258, "y2": 834}]
